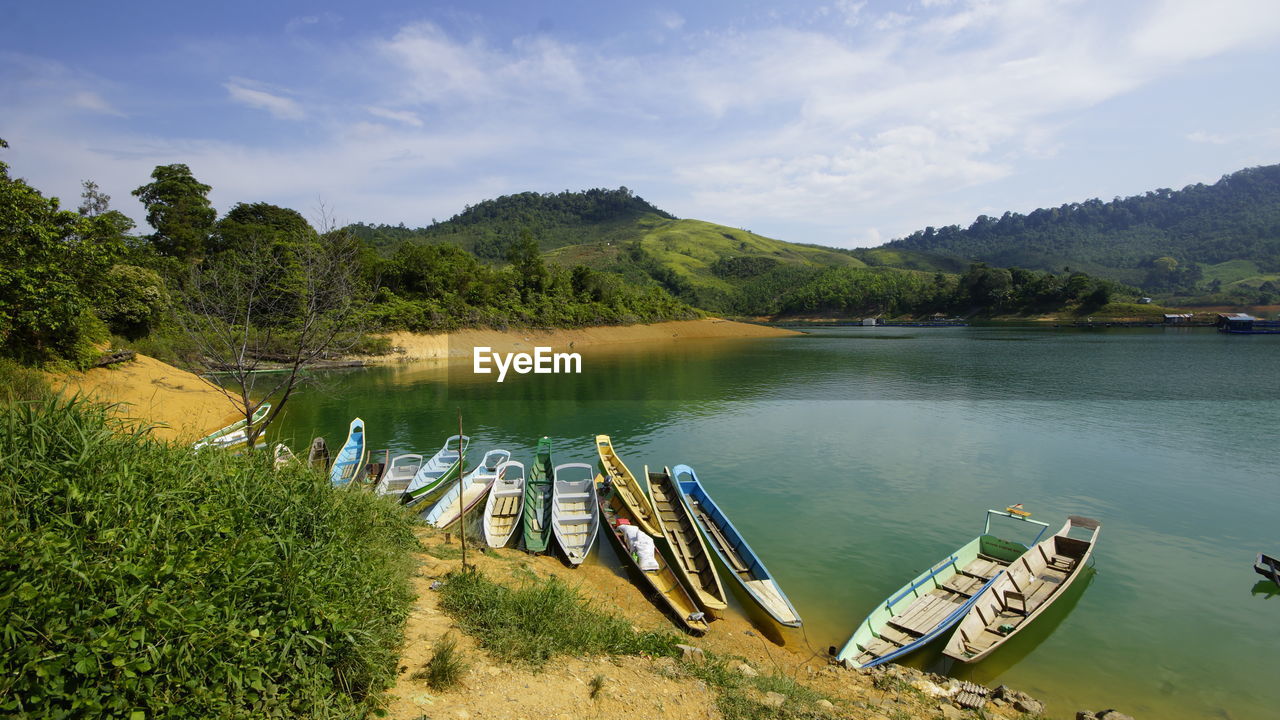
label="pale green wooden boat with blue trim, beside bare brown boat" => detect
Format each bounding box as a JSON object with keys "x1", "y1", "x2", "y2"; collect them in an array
[{"x1": 836, "y1": 510, "x2": 1048, "y2": 667}]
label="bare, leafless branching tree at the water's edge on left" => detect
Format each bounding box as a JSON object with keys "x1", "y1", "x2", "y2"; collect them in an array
[{"x1": 179, "y1": 226, "x2": 369, "y2": 450}]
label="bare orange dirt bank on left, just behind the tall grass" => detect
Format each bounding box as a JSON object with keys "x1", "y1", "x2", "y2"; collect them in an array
[{"x1": 50, "y1": 355, "x2": 238, "y2": 441}]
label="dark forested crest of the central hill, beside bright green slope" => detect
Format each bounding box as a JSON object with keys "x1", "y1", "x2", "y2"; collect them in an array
[{"x1": 349, "y1": 187, "x2": 675, "y2": 260}]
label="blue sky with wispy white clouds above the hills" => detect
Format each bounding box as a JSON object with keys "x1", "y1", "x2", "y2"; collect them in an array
[{"x1": 0, "y1": 0, "x2": 1280, "y2": 247}]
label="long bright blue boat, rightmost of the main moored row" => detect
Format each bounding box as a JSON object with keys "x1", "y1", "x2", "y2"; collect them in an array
[{"x1": 671, "y1": 465, "x2": 800, "y2": 628}]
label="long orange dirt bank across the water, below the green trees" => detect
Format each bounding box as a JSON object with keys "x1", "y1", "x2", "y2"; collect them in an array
[{"x1": 371, "y1": 318, "x2": 799, "y2": 363}]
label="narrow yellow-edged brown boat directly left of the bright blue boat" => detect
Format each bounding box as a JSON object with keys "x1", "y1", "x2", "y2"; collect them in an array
[{"x1": 644, "y1": 465, "x2": 728, "y2": 615}]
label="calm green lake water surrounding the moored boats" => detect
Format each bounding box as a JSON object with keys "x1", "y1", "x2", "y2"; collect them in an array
[{"x1": 278, "y1": 328, "x2": 1280, "y2": 719}]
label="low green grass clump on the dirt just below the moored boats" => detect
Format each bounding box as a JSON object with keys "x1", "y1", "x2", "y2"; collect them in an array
[{"x1": 440, "y1": 570, "x2": 678, "y2": 667}]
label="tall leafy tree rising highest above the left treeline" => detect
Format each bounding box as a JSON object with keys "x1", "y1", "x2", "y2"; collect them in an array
[{"x1": 133, "y1": 164, "x2": 218, "y2": 261}]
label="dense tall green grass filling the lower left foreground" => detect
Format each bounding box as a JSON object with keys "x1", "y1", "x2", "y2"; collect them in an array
[{"x1": 0, "y1": 400, "x2": 415, "y2": 720}]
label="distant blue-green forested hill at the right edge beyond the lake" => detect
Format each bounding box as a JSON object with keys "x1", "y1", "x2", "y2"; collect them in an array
[{"x1": 886, "y1": 165, "x2": 1280, "y2": 295}]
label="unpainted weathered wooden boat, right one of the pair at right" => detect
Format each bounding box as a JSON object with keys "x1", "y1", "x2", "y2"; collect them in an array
[{"x1": 942, "y1": 515, "x2": 1101, "y2": 662}]
